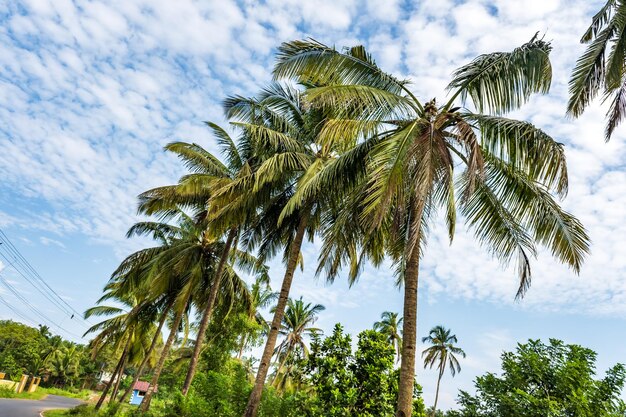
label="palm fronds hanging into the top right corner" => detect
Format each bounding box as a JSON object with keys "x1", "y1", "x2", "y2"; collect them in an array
[{"x1": 567, "y1": 0, "x2": 626, "y2": 141}]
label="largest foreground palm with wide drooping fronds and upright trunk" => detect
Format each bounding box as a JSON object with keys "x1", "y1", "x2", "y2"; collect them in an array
[{"x1": 274, "y1": 36, "x2": 589, "y2": 417}]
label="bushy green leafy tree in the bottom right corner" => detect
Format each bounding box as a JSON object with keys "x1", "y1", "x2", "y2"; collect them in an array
[{"x1": 448, "y1": 339, "x2": 626, "y2": 417}]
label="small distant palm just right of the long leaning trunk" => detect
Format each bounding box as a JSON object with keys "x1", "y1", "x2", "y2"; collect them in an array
[{"x1": 275, "y1": 297, "x2": 326, "y2": 382}]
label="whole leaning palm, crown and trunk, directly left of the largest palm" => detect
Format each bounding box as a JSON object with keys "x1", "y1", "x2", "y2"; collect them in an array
[{"x1": 212, "y1": 84, "x2": 352, "y2": 417}]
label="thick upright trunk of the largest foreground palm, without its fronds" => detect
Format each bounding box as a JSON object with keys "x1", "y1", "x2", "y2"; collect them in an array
[{"x1": 396, "y1": 199, "x2": 424, "y2": 417}]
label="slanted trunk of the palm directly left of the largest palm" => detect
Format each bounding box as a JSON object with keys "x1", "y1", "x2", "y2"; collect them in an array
[{"x1": 243, "y1": 215, "x2": 307, "y2": 417}]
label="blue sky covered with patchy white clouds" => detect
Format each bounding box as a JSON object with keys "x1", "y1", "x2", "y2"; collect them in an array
[{"x1": 0, "y1": 0, "x2": 626, "y2": 408}]
